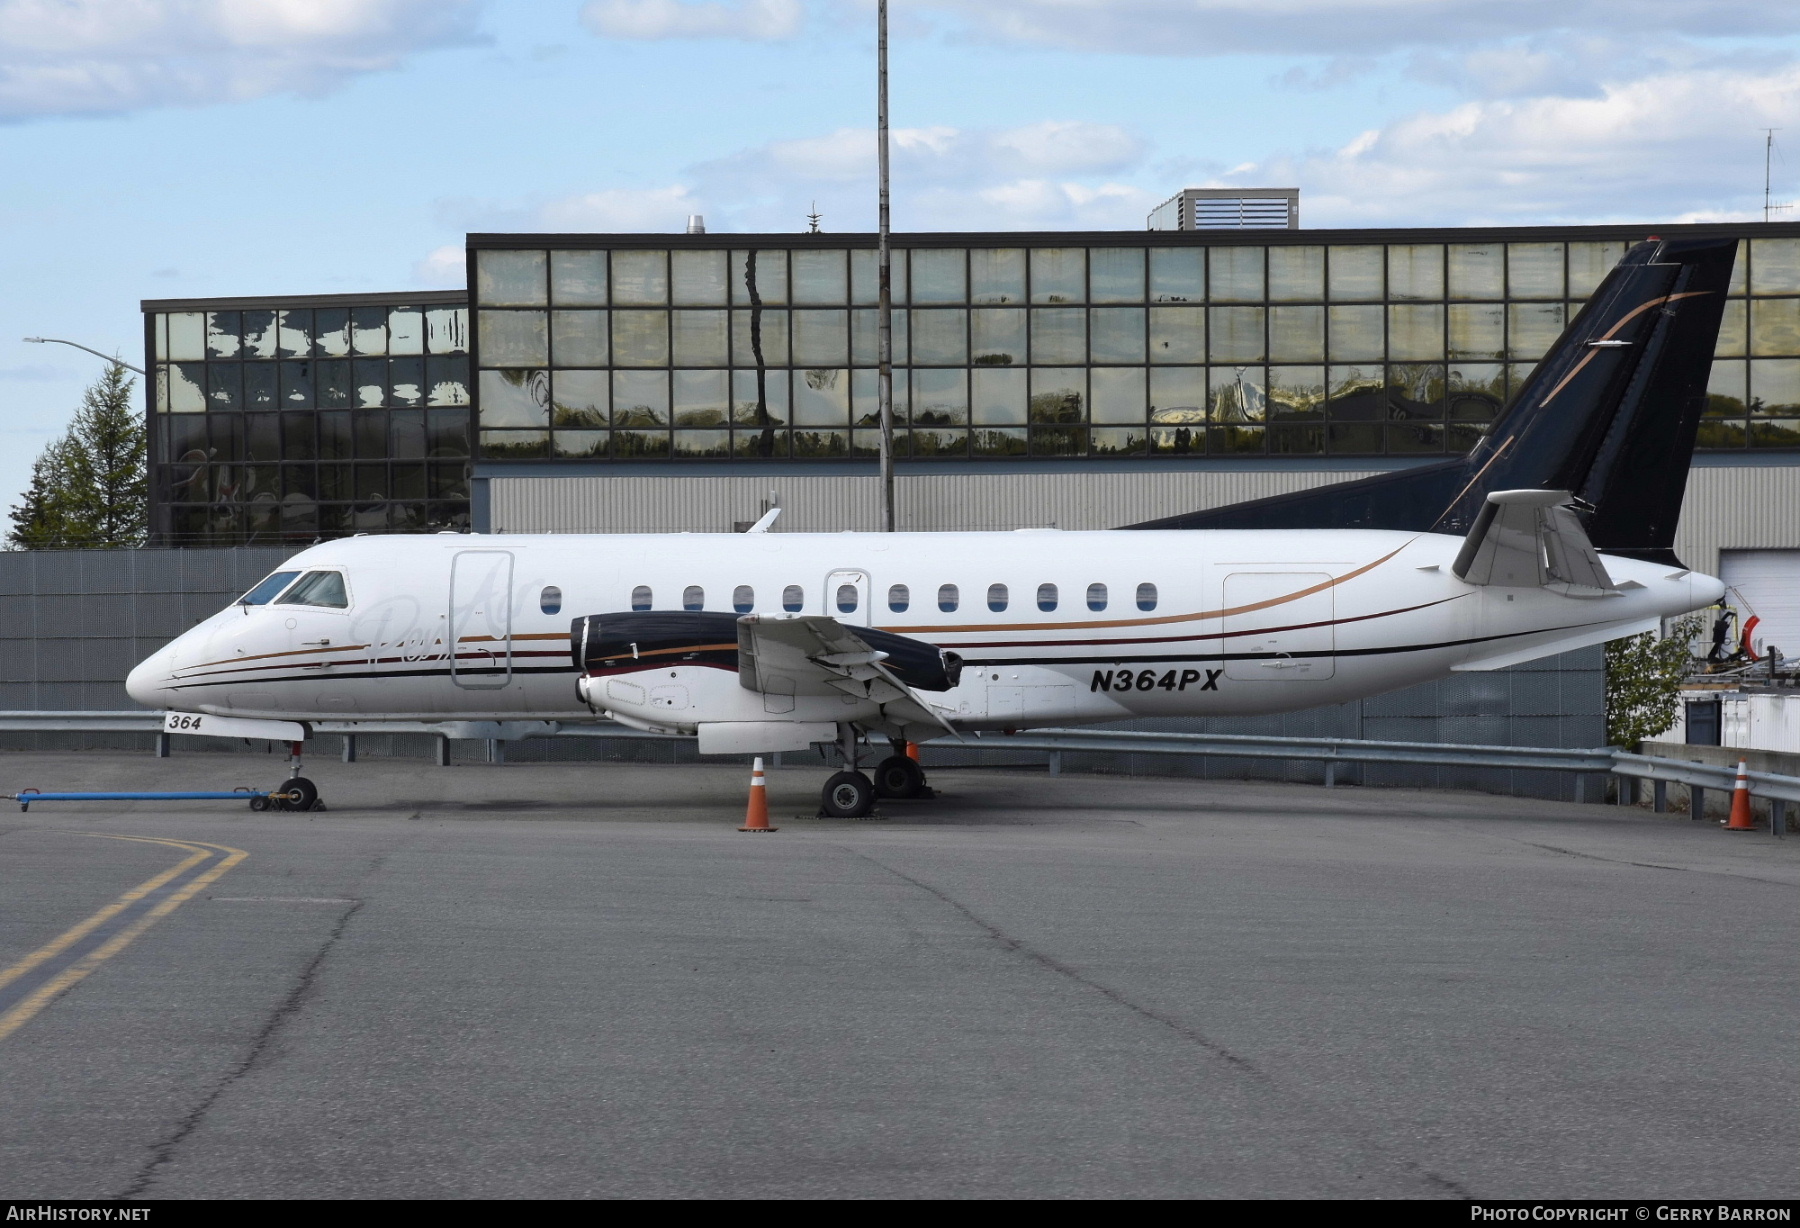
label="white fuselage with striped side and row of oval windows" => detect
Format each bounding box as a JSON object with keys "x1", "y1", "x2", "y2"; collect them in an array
[{"x1": 128, "y1": 529, "x2": 1723, "y2": 733}]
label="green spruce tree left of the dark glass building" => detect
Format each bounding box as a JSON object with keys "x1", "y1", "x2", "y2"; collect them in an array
[{"x1": 7, "y1": 362, "x2": 149, "y2": 549}]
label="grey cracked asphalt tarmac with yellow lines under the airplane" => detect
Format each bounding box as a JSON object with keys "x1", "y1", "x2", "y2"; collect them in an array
[{"x1": 0, "y1": 754, "x2": 1800, "y2": 1199}]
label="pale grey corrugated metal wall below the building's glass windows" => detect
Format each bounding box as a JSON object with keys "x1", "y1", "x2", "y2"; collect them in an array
[{"x1": 488, "y1": 465, "x2": 1800, "y2": 574}]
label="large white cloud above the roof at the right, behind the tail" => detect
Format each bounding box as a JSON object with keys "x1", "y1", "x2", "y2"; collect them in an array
[{"x1": 1228, "y1": 65, "x2": 1800, "y2": 225}]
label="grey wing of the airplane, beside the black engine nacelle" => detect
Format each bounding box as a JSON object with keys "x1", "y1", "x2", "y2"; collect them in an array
[{"x1": 738, "y1": 614, "x2": 956, "y2": 735}]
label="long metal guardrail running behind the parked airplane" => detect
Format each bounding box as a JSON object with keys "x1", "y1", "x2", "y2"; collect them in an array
[{"x1": 0, "y1": 711, "x2": 1800, "y2": 812}]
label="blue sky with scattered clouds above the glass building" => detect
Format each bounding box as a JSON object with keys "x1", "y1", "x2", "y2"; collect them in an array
[{"x1": 0, "y1": 0, "x2": 1800, "y2": 506}]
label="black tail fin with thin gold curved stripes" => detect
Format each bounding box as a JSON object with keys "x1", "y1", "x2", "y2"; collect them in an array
[{"x1": 1129, "y1": 238, "x2": 1737, "y2": 565}]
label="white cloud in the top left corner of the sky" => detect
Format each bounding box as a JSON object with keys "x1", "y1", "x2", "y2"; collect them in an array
[{"x1": 0, "y1": 0, "x2": 477, "y2": 121}]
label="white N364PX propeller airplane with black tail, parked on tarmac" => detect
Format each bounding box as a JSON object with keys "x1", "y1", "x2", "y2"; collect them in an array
[{"x1": 128, "y1": 241, "x2": 1732, "y2": 816}]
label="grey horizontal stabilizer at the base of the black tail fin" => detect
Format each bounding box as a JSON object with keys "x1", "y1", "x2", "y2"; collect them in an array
[{"x1": 1451, "y1": 490, "x2": 1618, "y2": 598}]
